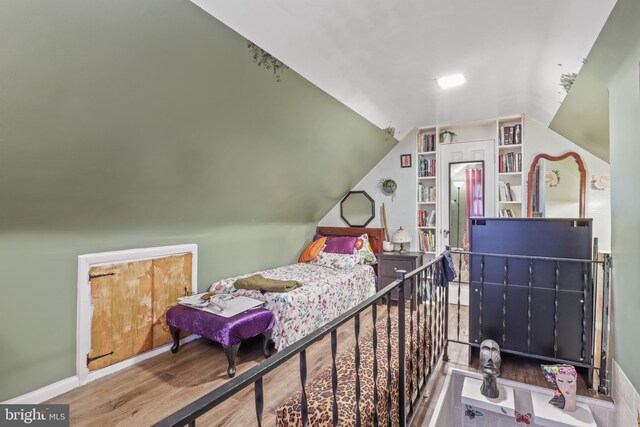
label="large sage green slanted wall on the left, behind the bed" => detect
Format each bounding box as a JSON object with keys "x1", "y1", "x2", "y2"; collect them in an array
[{"x1": 0, "y1": 0, "x2": 395, "y2": 401}]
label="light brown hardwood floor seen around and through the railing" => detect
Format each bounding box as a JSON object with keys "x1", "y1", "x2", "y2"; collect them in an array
[{"x1": 49, "y1": 305, "x2": 608, "y2": 427}]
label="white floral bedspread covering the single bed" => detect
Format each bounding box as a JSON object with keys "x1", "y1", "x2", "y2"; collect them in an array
[{"x1": 209, "y1": 263, "x2": 376, "y2": 351}]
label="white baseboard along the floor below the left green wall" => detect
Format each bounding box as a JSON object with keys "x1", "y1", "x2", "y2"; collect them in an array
[{"x1": 2, "y1": 335, "x2": 200, "y2": 405}]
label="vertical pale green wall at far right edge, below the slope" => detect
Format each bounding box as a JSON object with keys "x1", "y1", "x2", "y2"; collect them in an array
[{"x1": 609, "y1": 39, "x2": 640, "y2": 390}]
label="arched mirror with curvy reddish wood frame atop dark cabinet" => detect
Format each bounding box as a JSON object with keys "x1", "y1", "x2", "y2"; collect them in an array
[{"x1": 527, "y1": 151, "x2": 587, "y2": 218}]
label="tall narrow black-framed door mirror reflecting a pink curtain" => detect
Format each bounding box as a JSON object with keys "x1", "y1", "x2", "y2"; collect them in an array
[{"x1": 449, "y1": 161, "x2": 484, "y2": 249}]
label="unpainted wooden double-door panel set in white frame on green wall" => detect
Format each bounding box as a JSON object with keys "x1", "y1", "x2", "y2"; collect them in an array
[{"x1": 87, "y1": 254, "x2": 192, "y2": 371}]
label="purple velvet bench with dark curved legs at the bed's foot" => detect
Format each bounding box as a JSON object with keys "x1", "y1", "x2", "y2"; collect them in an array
[{"x1": 167, "y1": 305, "x2": 275, "y2": 378}]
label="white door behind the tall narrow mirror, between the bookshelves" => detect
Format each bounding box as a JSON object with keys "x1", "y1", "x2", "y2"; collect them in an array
[{"x1": 437, "y1": 139, "x2": 496, "y2": 305}]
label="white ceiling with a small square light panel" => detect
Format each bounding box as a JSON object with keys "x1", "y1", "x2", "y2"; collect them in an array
[{"x1": 192, "y1": 0, "x2": 615, "y2": 138}]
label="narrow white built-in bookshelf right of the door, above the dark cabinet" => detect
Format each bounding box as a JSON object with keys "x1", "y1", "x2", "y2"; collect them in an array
[{"x1": 496, "y1": 116, "x2": 524, "y2": 218}]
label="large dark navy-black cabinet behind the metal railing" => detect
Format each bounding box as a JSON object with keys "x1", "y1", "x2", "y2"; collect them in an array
[{"x1": 469, "y1": 218, "x2": 594, "y2": 363}]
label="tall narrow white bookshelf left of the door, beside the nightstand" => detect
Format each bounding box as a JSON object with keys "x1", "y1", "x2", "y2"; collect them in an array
[{"x1": 416, "y1": 127, "x2": 438, "y2": 255}]
